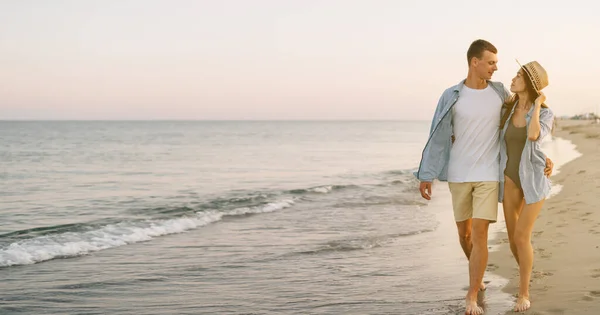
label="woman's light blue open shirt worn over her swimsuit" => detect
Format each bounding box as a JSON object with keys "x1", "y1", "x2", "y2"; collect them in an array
[{"x1": 498, "y1": 105, "x2": 554, "y2": 204}]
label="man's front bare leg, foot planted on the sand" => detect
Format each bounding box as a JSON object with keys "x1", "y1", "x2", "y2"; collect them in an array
[{"x1": 465, "y1": 219, "x2": 490, "y2": 315}]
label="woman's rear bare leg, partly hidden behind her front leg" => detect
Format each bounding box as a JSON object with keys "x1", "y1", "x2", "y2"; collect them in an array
[{"x1": 502, "y1": 176, "x2": 525, "y2": 265}]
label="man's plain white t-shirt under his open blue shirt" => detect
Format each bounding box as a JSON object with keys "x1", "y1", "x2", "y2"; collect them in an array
[{"x1": 448, "y1": 84, "x2": 502, "y2": 183}]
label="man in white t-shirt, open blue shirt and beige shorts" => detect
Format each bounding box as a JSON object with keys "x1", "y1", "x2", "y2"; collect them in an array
[{"x1": 415, "y1": 39, "x2": 552, "y2": 315}]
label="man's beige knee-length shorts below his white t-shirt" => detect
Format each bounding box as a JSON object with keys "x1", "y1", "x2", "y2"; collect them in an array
[{"x1": 448, "y1": 182, "x2": 499, "y2": 223}]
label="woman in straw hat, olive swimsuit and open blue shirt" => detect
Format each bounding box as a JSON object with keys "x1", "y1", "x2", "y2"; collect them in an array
[{"x1": 499, "y1": 61, "x2": 554, "y2": 312}]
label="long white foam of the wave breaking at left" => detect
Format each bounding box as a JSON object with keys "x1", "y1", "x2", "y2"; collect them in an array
[{"x1": 0, "y1": 200, "x2": 294, "y2": 267}]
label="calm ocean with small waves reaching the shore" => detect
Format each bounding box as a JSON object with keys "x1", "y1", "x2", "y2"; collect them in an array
[{"x1": 0, "y1": 121, "x2": 574, "y2": 315}]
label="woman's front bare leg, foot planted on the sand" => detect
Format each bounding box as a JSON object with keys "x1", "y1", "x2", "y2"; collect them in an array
[{"x1": 514, "y1": 200, "x2": 544, "y2": 312}]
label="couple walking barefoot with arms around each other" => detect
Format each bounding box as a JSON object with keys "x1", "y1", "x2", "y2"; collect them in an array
[{"x1": 415, "y1": 39, "x2": 554, "y2": 315}]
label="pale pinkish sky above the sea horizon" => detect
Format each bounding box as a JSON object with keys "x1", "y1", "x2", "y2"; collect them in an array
[{"x1": 0, "y1": 0, "x2": 600, "y2": 120}]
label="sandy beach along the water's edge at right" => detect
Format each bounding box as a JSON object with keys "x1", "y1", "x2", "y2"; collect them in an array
[{"x1": 488, "y1": 120, "x2": 600, "y2": 315}]
